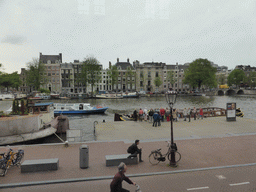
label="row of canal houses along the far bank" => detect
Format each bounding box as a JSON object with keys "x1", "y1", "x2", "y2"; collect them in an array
[{"x1": 20, "y1": 53, "x2": 228, "y2": 97}]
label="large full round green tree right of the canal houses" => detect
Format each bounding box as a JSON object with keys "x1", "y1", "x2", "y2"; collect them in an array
[{"x1": 183, "y1": 58, "x2": 217, "y2": 89}]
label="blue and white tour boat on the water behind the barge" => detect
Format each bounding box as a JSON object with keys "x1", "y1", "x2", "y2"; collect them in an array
[{"x1": 54, "y1": 103, "x2": 108, "y2": 115}]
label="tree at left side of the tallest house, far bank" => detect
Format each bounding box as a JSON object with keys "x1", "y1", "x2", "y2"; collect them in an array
[{"x1": 26, "y1": 58, "x2": 45, "y2": 90}]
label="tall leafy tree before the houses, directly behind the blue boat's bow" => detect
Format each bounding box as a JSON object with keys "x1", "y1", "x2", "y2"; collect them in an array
[{"x1": 82, "y1": 56, "x2": 101, "y2": 94}]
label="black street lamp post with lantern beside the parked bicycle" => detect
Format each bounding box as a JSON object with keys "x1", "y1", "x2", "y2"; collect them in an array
[{"x1": 165, "y1": 88, "x2": 177, "y2": 167}]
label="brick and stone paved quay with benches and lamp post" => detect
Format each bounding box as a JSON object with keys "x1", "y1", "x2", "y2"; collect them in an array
[{"x1": 0, "y1": 117, "x2": 256, "y2": 185}]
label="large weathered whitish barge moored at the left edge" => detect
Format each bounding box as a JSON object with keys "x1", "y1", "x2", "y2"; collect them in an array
[{"x1": 0, "y1": 102, "x2": 68, "y2": 145}]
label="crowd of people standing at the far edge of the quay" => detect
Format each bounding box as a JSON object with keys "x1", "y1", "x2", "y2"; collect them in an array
[{"x1": 132, "y1": 107, "x2": 203, "y2": 124}]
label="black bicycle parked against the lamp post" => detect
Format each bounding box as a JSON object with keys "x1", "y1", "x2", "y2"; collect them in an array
[{"x1": 149, "y1": 141, "x2": 181, "y2": 165}]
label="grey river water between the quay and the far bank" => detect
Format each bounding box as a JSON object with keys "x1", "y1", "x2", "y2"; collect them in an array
[{"x1": 0, "y1": 95, "x2": 256, "y2": 142}]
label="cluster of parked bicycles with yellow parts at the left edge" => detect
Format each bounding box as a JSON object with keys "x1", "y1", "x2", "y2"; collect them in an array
[{"x1": 0, "y1": 148, "x2": 24, "y2": 176}]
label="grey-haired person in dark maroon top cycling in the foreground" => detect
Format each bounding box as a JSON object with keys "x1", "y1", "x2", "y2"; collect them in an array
[{"x1": 110, "y1": 162, "x2": 136, "y2": 192}]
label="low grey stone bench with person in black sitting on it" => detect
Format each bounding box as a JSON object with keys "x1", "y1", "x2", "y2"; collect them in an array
[{"x1": 105, "y1": 154, "x2": 138, "y2": 167}]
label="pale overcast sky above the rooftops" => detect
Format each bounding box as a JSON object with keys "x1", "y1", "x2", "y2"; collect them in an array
[{"x1": 0, "y1": 0, "x2": 256, "y2": 73}]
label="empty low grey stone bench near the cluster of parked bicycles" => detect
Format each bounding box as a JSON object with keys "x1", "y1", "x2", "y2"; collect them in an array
[{"x1": 21, "y1": 158, "x2": 59, "y2": 173}]
